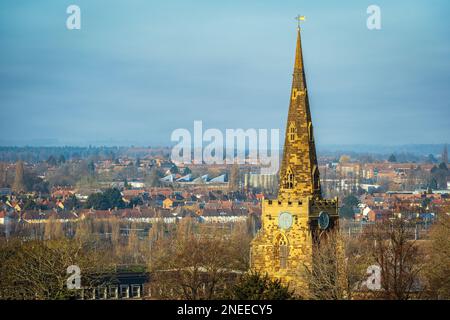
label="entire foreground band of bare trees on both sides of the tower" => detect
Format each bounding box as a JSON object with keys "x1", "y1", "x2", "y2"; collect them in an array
[{"x1": 0, "y1": 214, "x2": 450, "y2": 300}]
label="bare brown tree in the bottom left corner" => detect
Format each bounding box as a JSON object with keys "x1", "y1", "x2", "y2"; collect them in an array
[{"x1": 0, "y1": 239, "x2": 110, "y2": 300}]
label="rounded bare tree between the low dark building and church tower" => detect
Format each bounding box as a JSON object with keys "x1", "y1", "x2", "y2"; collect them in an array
[{"x1": 150, "y1": 219, "x2": 248, "y2": 300}]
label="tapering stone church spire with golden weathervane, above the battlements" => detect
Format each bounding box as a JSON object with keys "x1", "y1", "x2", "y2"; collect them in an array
[{"x1": 278, "y1": 25, "x2": 321, "y2": 200}]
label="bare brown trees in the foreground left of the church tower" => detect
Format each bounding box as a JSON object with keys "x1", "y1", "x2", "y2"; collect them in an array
[{"x1": 0, "y1": 218, "x2": 268, "y2": 299}]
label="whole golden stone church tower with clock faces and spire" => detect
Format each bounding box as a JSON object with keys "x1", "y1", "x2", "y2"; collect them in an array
[{"x1": 251, "y1": 28, "x2": 338, "y2": 295}]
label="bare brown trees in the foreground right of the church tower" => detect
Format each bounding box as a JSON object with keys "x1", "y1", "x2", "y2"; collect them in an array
[{"x1": 305, "y1": 214, "x2": 450, "y2": 300}]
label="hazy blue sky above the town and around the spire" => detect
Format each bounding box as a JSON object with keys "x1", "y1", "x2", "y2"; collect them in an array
[{"x1": 0, "y1": 0, "x2": 450, "y2": 147}]
